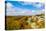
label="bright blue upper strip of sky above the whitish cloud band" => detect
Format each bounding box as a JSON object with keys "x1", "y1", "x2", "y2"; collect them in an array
[{"x1": 5, "y1": 1, "x2": 44, "y2": 10}]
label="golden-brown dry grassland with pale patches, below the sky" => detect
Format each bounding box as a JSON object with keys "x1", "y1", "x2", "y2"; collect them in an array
[{"x1": 5, "y1": 14, "x2": 45, "y2": 30}]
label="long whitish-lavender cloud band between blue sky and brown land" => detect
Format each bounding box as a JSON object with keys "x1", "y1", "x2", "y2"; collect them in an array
[{"x1": 6, "y1": 3, "x2": 44, "y2": 16}]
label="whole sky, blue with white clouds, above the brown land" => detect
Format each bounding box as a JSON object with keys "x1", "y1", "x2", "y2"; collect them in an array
[{"x1": 6, "y1": 1, "x2": 45, "y2": 15}]
